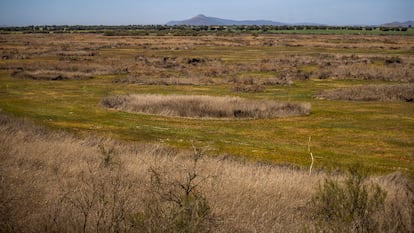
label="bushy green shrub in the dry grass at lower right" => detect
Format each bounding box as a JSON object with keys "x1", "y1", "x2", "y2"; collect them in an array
[{"x1": 311, "y1": 165, "x2": 386, "y2": 232}]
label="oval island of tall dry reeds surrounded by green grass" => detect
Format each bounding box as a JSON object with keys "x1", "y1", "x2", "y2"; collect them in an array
[{"x1": 102, "y1": 95, "x2": 310, "y2": 118}]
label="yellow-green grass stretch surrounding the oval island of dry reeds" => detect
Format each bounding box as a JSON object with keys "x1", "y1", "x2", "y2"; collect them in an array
[{"x1": 0, "y1": 69, "x2": 414, "y2": 175}]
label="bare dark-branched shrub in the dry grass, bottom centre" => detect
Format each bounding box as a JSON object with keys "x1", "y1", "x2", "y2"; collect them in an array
[{"x1": 133, "y1": 149, "x2": 216, "y2": 233}]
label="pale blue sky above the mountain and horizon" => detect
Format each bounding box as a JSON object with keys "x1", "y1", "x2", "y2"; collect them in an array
[{"x1": 0, "y1": 0, "x2": 414, "y2": 26}]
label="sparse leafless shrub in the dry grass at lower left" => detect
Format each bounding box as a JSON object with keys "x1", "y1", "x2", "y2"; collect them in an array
[{"x1": 45, "y1": 157, "x2": 139, "y2": 232}]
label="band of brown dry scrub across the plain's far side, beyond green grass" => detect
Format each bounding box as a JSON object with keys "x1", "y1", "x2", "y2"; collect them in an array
[{"x1": 0, "y1": 34, "x2": 414, "y2": 84}]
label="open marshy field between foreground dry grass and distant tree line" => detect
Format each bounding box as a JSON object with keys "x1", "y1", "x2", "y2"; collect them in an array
[{"x1": 0, "y1": 31, "x2": 414, "y2": 176}]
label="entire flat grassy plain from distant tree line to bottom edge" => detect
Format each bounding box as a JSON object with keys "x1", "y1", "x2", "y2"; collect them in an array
[{"x1": 0, "y1": 33, "x2": 414, "y2": 232}]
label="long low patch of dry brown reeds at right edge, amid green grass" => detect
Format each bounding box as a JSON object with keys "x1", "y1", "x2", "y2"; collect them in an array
[{"x1": 318, "y1": 84, "x2": 414, "y2": 102}]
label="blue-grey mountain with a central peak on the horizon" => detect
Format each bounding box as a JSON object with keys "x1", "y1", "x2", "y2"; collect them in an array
[{"x1": 167, "y1": 15, "x2": 287, "y2": 26}]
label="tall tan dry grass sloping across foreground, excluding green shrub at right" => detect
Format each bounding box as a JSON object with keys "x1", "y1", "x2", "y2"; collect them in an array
[{"x1": 0, "y1": 113, "x2": 414, "y2": 232}]
